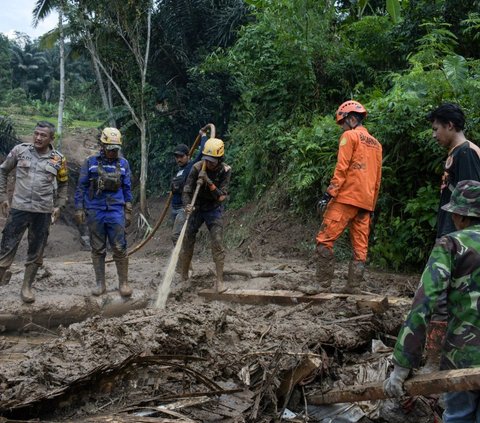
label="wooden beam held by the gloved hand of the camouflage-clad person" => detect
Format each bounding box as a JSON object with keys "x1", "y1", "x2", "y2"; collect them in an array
[{"x1": 307, "y1": 368, "x2": 480, "y2": 405}]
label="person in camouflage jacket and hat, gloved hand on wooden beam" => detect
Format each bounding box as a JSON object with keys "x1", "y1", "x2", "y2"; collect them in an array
[{"x1": 384, "y1": 180, "x2": 480, "y2": 423}]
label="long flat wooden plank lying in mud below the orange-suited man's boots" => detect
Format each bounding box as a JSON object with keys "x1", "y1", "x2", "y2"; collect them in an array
[{"x1": 198, "y1": 289, "x2": 389, "y2": 313}]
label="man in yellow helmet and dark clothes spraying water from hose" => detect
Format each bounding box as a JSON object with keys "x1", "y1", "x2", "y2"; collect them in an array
[{"x1": 179, "y1": 138, "x2": 231, "y2": 292}]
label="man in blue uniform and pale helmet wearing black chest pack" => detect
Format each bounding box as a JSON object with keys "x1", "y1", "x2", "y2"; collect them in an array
[{"x1": 75, "y1": 128, "x2": 132, "y2": 297}]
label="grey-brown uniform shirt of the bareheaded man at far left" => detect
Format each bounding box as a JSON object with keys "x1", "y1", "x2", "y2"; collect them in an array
[{"x1": 0, "y1": 143, "x2": 68, "y2": 213}]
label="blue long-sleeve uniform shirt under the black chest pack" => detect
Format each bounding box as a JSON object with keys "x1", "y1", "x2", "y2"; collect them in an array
[{"x1": 75, "y1": 152, "x2": 132, "y2": 210}]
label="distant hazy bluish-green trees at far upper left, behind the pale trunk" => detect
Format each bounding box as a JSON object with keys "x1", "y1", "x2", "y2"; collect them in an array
[{"x1": 0, "y1": 33, "x2": 105, "y2": 124}]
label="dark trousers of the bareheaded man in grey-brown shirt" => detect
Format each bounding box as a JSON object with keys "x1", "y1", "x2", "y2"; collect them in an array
[{"x1": 0, "y1": 209, "x2": 52, "y2": 268}]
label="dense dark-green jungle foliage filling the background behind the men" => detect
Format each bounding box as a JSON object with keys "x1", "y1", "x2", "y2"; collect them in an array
[{"x1": 0, "y1": 0, "x2": 480, "y2": 269}]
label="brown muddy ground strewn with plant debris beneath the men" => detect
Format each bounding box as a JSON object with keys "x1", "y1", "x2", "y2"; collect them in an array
[{"x1": 0, "y1": 134, "x2": 439, "y2": 422}]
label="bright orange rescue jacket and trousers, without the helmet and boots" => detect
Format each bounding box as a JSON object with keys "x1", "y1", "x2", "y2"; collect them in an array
[{"x1": 316, "y1": 126, "x2": 382, "y2": 261}]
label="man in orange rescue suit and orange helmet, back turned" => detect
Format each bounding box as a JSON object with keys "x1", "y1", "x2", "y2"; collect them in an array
[{"x1": 316, "y1": 100, "x2": 382, "y2": 293}]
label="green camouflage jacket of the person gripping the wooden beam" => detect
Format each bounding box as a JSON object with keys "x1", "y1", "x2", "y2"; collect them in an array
[{"x1": 393, "y1": 225, "x2": 480, "y2": 370}]
